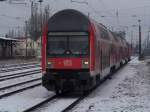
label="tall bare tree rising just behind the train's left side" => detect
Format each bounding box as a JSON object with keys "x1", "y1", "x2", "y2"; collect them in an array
[{"x1": 25, "y1": 4, "x2": 50, "y2": 41}]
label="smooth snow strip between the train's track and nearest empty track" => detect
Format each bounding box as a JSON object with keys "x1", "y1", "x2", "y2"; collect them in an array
[{"x1": 0, "y1": 86, "x2": 54, "y2": 112}]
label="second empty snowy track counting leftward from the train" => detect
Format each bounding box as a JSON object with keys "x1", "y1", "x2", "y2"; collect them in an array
[{"x1": 0, "y1": 69, "x2": 41, "y2": 81}]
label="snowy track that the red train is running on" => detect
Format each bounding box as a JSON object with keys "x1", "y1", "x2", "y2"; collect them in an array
[{"x1": 23, "y1": 61, "x2": 131, "y2": 112}]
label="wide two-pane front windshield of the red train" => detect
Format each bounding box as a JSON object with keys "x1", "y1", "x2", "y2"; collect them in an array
[{"x1": 47, "y1": 32, "x2": 89, "y2": 57}]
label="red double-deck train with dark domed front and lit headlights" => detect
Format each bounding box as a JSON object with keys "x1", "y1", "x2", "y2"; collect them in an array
[{"x1": 42, "y1": 9, "x2": 131, "y2": 93}]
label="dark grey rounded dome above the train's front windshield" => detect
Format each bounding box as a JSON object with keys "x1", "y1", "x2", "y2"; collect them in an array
[{"x1": 48, "y1": 9, "x2": 90, "y2": 32}]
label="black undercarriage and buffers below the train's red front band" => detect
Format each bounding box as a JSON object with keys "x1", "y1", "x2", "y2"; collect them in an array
[{"x1": 42, "y1": 69, "x2": 98, "y2": 94}]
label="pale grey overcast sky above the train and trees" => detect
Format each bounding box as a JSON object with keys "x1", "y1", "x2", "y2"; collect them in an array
[{"x1": 0, "y1": 0, "x2": 150, "y2": 43}]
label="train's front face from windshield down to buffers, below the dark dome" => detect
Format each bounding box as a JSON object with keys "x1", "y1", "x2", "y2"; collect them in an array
[{"x1": 42, "y1": 32, "x2": 90, "y2": 91}]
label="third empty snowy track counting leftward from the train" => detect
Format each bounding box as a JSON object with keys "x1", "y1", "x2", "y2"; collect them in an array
[{"x1": 0, "y1": 65, "x2": 40, "y2": 73}]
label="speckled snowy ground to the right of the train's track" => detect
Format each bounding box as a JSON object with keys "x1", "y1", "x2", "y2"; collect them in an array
[{"x1": 72, "y1": 58, "x2": 150, "y2": 112}]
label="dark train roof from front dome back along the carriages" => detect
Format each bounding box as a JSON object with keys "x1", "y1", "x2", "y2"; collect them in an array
[{"x1": 48, "y1": 9, "x2": 129, "y2": 45}]
